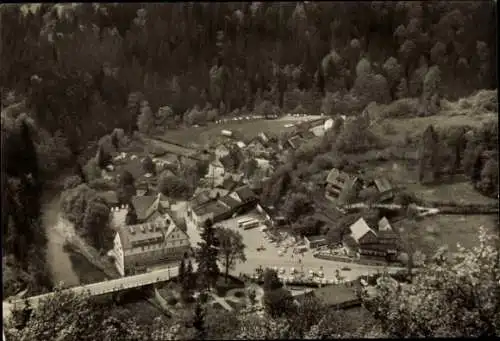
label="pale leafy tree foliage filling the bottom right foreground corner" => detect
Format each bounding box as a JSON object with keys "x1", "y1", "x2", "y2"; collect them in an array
[{"x1": 370, "y1": 229, "x2": 500, "y2": 337}]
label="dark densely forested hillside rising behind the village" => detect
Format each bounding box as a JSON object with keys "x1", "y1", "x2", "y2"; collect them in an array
[{"x1": 0, "y1": 1, "x2": 496, "y2": 152}]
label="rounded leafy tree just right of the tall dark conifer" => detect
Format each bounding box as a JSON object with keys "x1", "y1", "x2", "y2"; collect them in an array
[{"x1": 216, "y1": 228, "x2": 246, "y2": 282}]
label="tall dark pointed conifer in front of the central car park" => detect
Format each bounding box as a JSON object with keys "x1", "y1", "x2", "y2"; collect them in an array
[{"x1": 196, "y1": 219, "x2": 220, "y2": 289}]
